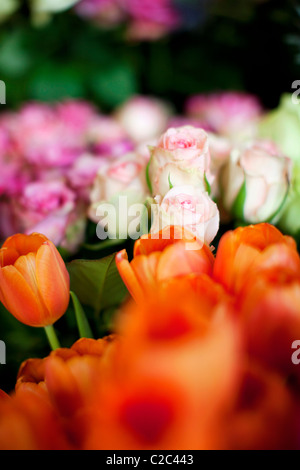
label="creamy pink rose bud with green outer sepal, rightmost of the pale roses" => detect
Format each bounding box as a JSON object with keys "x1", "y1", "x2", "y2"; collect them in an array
[{"x1": 222, "y1": 142, "x2": 291, "y2": 223}]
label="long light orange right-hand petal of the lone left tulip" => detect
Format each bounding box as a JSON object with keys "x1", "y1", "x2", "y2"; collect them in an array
[{"x1": 36, "y1": 241, "x2": 70, "y2": 325}]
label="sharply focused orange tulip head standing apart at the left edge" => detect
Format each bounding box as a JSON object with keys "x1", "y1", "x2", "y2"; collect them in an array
[{"x1": 0, "y1": 233, "x2": 70, "y2": 327}]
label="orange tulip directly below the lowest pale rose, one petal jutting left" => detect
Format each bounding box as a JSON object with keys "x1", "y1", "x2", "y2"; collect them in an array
[{"x1": 116, "y1": 226, "x2": 214, "y2": 301}]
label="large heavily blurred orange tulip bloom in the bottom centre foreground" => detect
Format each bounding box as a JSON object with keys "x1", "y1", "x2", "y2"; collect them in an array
[{"x1": 85, "y1": 275, "x2": 240, "y2": 450}]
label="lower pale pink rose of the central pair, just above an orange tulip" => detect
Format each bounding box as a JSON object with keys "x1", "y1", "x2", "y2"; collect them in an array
[{"x1": 151, "y1": 186, "x2": 220, "y2": 245}]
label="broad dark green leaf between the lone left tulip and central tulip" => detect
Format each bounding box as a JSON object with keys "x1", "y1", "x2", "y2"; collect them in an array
[{"x1": 67, "y1": 254, "x2": 127, "y2": 315}]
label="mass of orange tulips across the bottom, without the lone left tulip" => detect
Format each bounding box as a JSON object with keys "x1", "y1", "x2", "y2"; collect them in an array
[{"x1": 0, "y1": 224, "x2": 300, "y2": 450}]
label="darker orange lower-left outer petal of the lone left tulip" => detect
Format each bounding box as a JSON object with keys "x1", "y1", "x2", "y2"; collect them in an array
[{"x1": 0, "y1": 266, "x2": 45, "y2": 326}]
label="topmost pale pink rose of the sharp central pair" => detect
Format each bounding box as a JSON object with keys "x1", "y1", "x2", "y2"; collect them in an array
[{"x1": 148, "y1": 126, "x2": 210, "y2": 196}]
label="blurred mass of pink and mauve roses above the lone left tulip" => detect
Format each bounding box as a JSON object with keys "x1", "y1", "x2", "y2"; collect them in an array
[{"x1": 0, "y1": 97, "x2": 169, "y2": 251}]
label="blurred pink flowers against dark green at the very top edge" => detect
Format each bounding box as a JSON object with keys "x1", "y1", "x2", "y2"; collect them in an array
[{"x1": 75, "y1": 0, "x2": 181, "y2": 40}]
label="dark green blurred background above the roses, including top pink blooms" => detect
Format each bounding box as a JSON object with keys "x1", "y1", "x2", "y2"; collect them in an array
[{"x1": 0, "y1": 0, "x2": 300, "y2": 111}]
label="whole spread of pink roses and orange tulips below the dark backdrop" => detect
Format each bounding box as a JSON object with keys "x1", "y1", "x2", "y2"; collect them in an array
[{"x1": 0, "y1": 88, "x2": 300, "y2": 450}]
